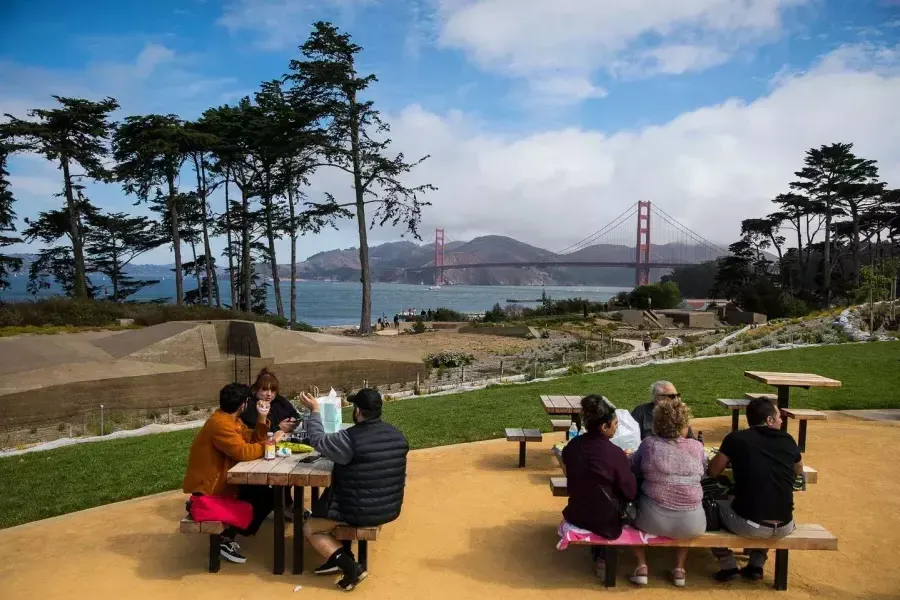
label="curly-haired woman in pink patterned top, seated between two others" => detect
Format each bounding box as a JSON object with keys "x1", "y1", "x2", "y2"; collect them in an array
[{"x1": 631, "y1": 399, "x2": 706, "y2": 587}]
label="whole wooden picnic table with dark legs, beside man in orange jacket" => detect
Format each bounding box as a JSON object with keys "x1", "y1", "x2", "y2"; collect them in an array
[{"x1": 227, "y1": 452, "x2": 334, "y2": 575}]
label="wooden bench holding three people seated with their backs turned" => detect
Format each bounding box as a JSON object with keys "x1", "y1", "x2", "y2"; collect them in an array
[{"x1": 569, "y1": 524, "x2": 838, "y2": 591}]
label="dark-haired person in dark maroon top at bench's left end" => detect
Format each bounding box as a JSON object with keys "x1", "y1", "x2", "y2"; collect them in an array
[{"x1": 562, "y1": 395, "x2": 637, "y2": 578}]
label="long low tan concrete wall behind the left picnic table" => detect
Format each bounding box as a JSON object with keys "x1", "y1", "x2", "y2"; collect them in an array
[{"x1": 0, "y1": 358, "x2": 425, "y2": 426}]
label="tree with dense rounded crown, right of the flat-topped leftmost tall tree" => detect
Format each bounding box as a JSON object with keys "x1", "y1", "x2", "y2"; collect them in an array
[{"x1": 113, "y1": 115, "x2": 189, "y2": 306}]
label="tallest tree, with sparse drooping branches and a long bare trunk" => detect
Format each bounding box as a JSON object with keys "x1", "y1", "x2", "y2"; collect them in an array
[{"x1": 285, "y1": 21, "x2": 436, "y2": 334}]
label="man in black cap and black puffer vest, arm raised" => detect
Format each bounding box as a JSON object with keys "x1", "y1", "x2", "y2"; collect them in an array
[{"x1": 300, "y1": 388, "x2": 409, "y2": 591}]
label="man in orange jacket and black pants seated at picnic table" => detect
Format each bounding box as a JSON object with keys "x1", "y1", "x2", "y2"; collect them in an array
[{"x1": 181, "y1": 383, "x2": 284, "y2": 563}]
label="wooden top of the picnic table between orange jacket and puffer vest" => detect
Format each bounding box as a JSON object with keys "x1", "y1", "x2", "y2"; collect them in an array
[{"x1": 227, "y1": 452, "x2": 334, "y2": 487}]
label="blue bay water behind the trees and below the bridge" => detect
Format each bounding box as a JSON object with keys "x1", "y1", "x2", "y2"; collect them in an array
[{"x1": 0, "y1": 276, "x2": 627, "y2": 327}]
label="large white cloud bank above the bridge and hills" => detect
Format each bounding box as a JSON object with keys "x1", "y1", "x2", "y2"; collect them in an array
[{"x1": 348, "y1": 42, "x2": 900, "y2": 250}]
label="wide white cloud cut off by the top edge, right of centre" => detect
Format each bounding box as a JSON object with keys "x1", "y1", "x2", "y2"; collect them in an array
[{"x1": 434, "y1": 0, "x2": 812, "y2": 101}]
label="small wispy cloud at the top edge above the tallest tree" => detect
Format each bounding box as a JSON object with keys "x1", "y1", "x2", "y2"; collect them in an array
[{"x1": 217, "y1": 0, "x2": 378, "y2": 50}]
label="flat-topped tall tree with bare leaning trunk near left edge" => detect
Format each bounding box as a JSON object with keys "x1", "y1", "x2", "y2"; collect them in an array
[{"x1": 0, "y1": 96, "x2": 119, "y2": 298}]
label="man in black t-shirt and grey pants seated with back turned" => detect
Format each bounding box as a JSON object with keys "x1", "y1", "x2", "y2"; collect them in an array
[{"x1": 709, "y1": 398, "x2": 803, "y2": 581}]
